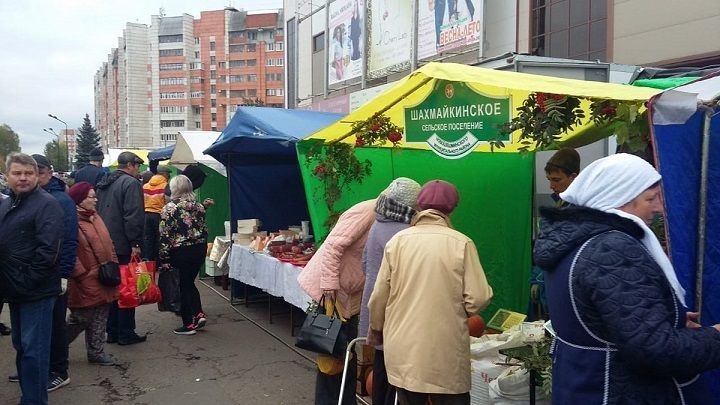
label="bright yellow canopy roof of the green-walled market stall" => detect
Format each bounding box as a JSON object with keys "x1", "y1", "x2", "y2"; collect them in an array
[{"x1": 306, "y1": 63, "x2": 660, "y2": 152}]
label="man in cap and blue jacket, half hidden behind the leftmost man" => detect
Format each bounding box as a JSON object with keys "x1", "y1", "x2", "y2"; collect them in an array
[{"x1": 32, "y1": 155, "x2": 78, "y2": 391}]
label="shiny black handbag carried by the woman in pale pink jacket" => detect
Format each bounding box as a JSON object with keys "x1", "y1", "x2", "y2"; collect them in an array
[{"x1": 295, "y1": 296, "x2": 348, "y2": 357}]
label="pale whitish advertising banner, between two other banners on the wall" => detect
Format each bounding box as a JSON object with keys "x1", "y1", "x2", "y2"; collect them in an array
[{"x1": 368, "y1": 0, "x2": 414, "y2": 77}]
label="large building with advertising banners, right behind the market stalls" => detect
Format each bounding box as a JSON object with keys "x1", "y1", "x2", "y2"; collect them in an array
[{"x1": 284, "y1": 0, "x2": 720, "y2": 113}]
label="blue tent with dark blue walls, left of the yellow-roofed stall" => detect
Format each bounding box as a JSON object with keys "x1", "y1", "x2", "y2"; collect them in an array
[{"x1": 205, "y1": 107, "x2": 343, "y2": 231}]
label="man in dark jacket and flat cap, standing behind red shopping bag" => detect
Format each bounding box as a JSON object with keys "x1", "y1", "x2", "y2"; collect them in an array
[{"x1": 95, "y1": 152, "x2": 147, "y2": 345}]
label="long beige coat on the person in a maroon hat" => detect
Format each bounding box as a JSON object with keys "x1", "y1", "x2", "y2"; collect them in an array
[{"x1": 368, "y1": 209, "x2": 493, "y2": 394}]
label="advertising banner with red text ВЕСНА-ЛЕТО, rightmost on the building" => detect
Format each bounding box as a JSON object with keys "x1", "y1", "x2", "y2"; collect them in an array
[{"x1": 418, "y1": 0, "x2": 483, "y2": 59}]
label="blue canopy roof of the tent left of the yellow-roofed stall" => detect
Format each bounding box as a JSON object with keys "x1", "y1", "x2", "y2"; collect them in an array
[{"x1": 205, "y1": 107, "x2": 343, "y2": 165}]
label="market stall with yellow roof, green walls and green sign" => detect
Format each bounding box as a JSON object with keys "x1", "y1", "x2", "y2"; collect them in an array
[{"x1": 297, "y1": 63, "x2": 658, "y2": 314}]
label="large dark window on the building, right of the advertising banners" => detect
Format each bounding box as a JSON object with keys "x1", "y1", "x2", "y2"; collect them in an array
[{"x1": 530, "y1": 0, "x2": 608, "y2": 61}]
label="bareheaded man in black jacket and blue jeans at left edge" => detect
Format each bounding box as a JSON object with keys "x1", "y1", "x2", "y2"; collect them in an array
[{"x1": 0, "y1": 153, "x2": 63, "y2": 404}]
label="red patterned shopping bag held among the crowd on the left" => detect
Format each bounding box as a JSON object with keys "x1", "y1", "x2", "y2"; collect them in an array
[{"x1": 118, "y1": 256, "x2": 162, "y2": 309}]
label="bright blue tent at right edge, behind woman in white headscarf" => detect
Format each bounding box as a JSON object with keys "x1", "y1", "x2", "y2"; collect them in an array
[{"x1": 649, "y1": 74, "x2": 720, "y2": 405}]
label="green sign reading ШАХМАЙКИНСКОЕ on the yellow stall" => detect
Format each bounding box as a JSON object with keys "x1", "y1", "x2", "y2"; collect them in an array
[{"x1": 405, "y1": 80, "x2": 510, "y2": 159}]
